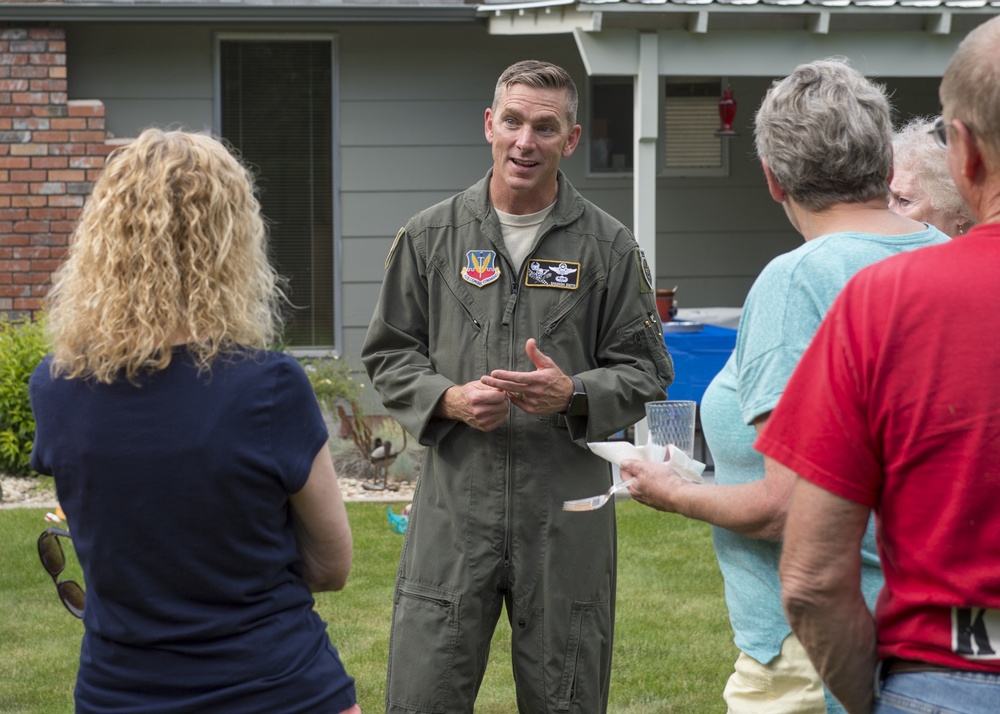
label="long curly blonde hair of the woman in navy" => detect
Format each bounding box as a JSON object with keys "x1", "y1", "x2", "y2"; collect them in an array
[{"x1": 48, "y1": 130, "x2": 281, "y2": 384}]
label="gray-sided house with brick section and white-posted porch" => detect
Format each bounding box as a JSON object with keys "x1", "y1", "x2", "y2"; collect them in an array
[{"x1": 0, "y1": 0, "x2": 1000, "y2": 404}]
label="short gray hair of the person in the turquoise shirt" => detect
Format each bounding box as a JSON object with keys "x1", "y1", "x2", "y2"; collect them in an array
[{"x1": 754, "y1": 57, "x2": 892, "y2": 211}]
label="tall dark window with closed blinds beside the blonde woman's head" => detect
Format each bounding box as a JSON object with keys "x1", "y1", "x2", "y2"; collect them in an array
[{"x1": 219, "y1": 38, "x2": 334, "y2": 348}]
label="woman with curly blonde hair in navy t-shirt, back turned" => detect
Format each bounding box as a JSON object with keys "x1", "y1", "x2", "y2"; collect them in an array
[{"x1": 30, "y1": 129, "x2": 360, "y2": 714}]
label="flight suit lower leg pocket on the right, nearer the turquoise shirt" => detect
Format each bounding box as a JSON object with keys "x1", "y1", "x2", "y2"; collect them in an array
[{"x1": 556, "y1": 602, "x2": 611, "y2": 711}]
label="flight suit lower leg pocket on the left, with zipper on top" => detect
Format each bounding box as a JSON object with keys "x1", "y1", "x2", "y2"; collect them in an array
[{"x1": 387, "y1": 579, "x2": 460, "y2": 713}]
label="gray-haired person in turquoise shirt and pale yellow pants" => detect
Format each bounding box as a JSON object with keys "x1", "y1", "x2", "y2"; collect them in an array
[{"x1": 622, "y1": 58, "x2": 948, "y2": 714}]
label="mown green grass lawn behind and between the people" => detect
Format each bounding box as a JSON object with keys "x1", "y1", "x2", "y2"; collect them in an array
[{"x1": 0, "y1": 502, "x2": 737, "y2": 714}]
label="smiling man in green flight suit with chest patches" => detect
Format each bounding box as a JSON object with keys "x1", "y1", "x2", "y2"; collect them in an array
[{"x1": 363, "y1": 60, "x2": 673, "y2": 714}]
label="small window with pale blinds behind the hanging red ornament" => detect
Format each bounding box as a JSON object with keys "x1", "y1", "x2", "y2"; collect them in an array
[{"x1": 663, "y1": 82, "x2": 723, "y2": 169}]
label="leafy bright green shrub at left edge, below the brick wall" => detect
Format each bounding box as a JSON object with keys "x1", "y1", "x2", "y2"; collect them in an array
[{"x1": 0, "y1": 313, "x2": 48, "y2": 476}]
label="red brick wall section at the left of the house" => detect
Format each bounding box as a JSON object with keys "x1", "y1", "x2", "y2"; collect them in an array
[{"x1": 0, "y1": 23, "x2": 115, "y2": 317}]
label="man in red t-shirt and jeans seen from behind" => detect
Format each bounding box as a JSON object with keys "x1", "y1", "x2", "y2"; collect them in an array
[{"x1": 756, "y1": 13, "x2": 1000, "y2": 714}]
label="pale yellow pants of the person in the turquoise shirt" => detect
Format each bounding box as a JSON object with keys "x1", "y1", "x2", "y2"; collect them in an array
[{"x1": 722, "y1": 635, "x2": 826, "y2": 714}]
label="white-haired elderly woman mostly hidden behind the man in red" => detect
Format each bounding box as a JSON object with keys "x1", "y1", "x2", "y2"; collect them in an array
[{"x1": 889, "y1": 117, "x2": 976, "y2": 236}]
